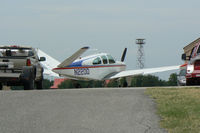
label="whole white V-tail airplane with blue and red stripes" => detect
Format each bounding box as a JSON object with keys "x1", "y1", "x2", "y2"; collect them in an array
[{"x1": 38, "y1": 47, "x2": 179, "y2": 80}]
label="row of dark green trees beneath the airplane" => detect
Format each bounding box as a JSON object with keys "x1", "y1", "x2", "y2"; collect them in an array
[{"x1": 58, "y1": 73, "x2": 177, "y2": 89}]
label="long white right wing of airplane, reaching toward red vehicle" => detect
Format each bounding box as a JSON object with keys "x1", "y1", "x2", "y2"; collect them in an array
[{"x1": 105, "y1": 65, "x2": 180, "y2": 79}]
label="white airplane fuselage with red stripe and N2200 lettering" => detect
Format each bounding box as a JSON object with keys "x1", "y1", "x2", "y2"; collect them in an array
[{"x1": 53, "y1": 53, "x2": 126, "y2": 80}]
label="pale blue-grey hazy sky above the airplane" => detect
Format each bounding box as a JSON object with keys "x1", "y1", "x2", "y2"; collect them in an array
[{"x1": 0, "y1": 0, "x2": 200, "y2": 78}]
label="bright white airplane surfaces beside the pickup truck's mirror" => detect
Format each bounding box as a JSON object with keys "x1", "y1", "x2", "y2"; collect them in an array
[{"x1": 37, "y1": 49, "x2": 60, "y2": 77}]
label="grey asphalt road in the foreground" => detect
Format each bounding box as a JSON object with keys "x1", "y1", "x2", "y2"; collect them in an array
[{"x1": 0, "y1": 88, "x2": 165, "y2": 133}]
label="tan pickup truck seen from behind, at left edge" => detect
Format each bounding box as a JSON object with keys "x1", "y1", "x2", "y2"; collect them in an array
[{"x1": 0, "y1": 46, "x2": 45, "y2": 90}]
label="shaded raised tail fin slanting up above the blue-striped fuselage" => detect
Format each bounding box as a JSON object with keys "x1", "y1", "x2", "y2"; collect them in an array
[{"x1": 55, "y1": 47, "x2": 89, "y2": 68}]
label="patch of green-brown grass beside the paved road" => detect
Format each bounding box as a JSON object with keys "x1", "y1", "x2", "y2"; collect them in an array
[{"x1": 146, "y1": 88, "x2": 200, "y2": 133}]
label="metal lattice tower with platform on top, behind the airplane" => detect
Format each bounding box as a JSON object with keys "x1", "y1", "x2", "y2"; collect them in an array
[{"x1": 136, "y1": 39, "x2": 145, "y2": 69}]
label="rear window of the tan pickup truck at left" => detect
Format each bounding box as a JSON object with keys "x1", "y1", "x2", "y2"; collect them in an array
[{"x1": 0, "y1": 48, "x2": 34, "y2": 57}]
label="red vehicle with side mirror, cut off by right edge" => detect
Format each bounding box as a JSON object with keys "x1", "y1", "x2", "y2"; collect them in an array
[{"x1": 182, "y1": 42, "x2": 200, "y2": 85}]
